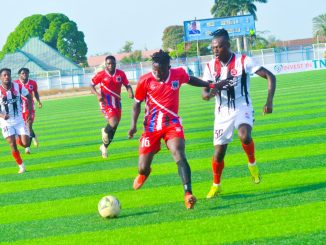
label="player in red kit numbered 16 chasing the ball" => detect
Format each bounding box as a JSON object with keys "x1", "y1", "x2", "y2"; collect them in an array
[{"x1": 128, "y1": 50, "x2": 218, "y2": 209}]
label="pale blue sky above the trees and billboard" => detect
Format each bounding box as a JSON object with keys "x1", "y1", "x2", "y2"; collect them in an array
[{"x1": 0, "y1": 0, "x2": 326, "y2": 55}]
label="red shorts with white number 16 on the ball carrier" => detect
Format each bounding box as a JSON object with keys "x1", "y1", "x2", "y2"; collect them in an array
[{"x1": 139, "y1": 124, "x2": 184, "y2": 154}]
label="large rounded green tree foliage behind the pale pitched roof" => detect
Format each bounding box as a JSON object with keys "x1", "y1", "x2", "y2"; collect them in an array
[{"x1": 0, "y1": 13, "x2": 87, "y2": 65}]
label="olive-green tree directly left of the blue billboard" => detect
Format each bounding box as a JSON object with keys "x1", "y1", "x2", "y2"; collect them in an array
[{"x1": 162, "y1": 26, "x2": 183, "y2": 50}]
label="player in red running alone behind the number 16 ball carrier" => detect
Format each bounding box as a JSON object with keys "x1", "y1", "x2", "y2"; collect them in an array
[{"x1": 90, "y1": 55, "x2": 134, "y2": 158}]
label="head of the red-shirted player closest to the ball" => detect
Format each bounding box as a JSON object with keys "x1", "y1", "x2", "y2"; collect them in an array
[{"x1": 152, "y1": 50, "x2": 171, "y2": 82}]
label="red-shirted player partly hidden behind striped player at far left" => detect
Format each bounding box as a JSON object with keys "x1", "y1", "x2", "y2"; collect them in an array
[{"x1": 15, "y1": 68, "x2": 42, "y2": 154}]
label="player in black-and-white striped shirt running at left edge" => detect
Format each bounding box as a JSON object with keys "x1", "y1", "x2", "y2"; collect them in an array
[{"x1": 0, "y1": 68, "x2": 32, "y2": 174}]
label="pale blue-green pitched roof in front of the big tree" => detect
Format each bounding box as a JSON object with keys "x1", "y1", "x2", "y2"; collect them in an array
[{"x1": 0, "y1": 37, "x2": 80, "y2": 72}]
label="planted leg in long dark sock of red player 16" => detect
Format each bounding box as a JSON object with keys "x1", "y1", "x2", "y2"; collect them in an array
[{"x1": 166, "y1": 136, "x2": 196, "y2": 209}]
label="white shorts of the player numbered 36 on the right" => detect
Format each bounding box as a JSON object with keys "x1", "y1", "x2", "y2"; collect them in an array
[{"x1": 214, "y1": 105, "x2": 254, "y2": 145}]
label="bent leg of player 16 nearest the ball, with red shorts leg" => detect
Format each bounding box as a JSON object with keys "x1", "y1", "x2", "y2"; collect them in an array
[{"x1": 133, "y1": 132, "x2": 161, "y2": 190}]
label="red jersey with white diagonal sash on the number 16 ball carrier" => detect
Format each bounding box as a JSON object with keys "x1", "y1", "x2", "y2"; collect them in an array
[{"x1": 135, "y1": 68, "x2": 189, "y2": 132}]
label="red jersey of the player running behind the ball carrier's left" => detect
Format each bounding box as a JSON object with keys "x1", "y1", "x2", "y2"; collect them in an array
[{"x1": 91, "y1": 69, "x2": 129, "y2": 105}]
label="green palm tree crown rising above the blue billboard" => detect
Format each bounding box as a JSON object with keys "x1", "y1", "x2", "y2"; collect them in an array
[{"x1": 211, "y1": 0, "x2": 267, "y2": 20}]
